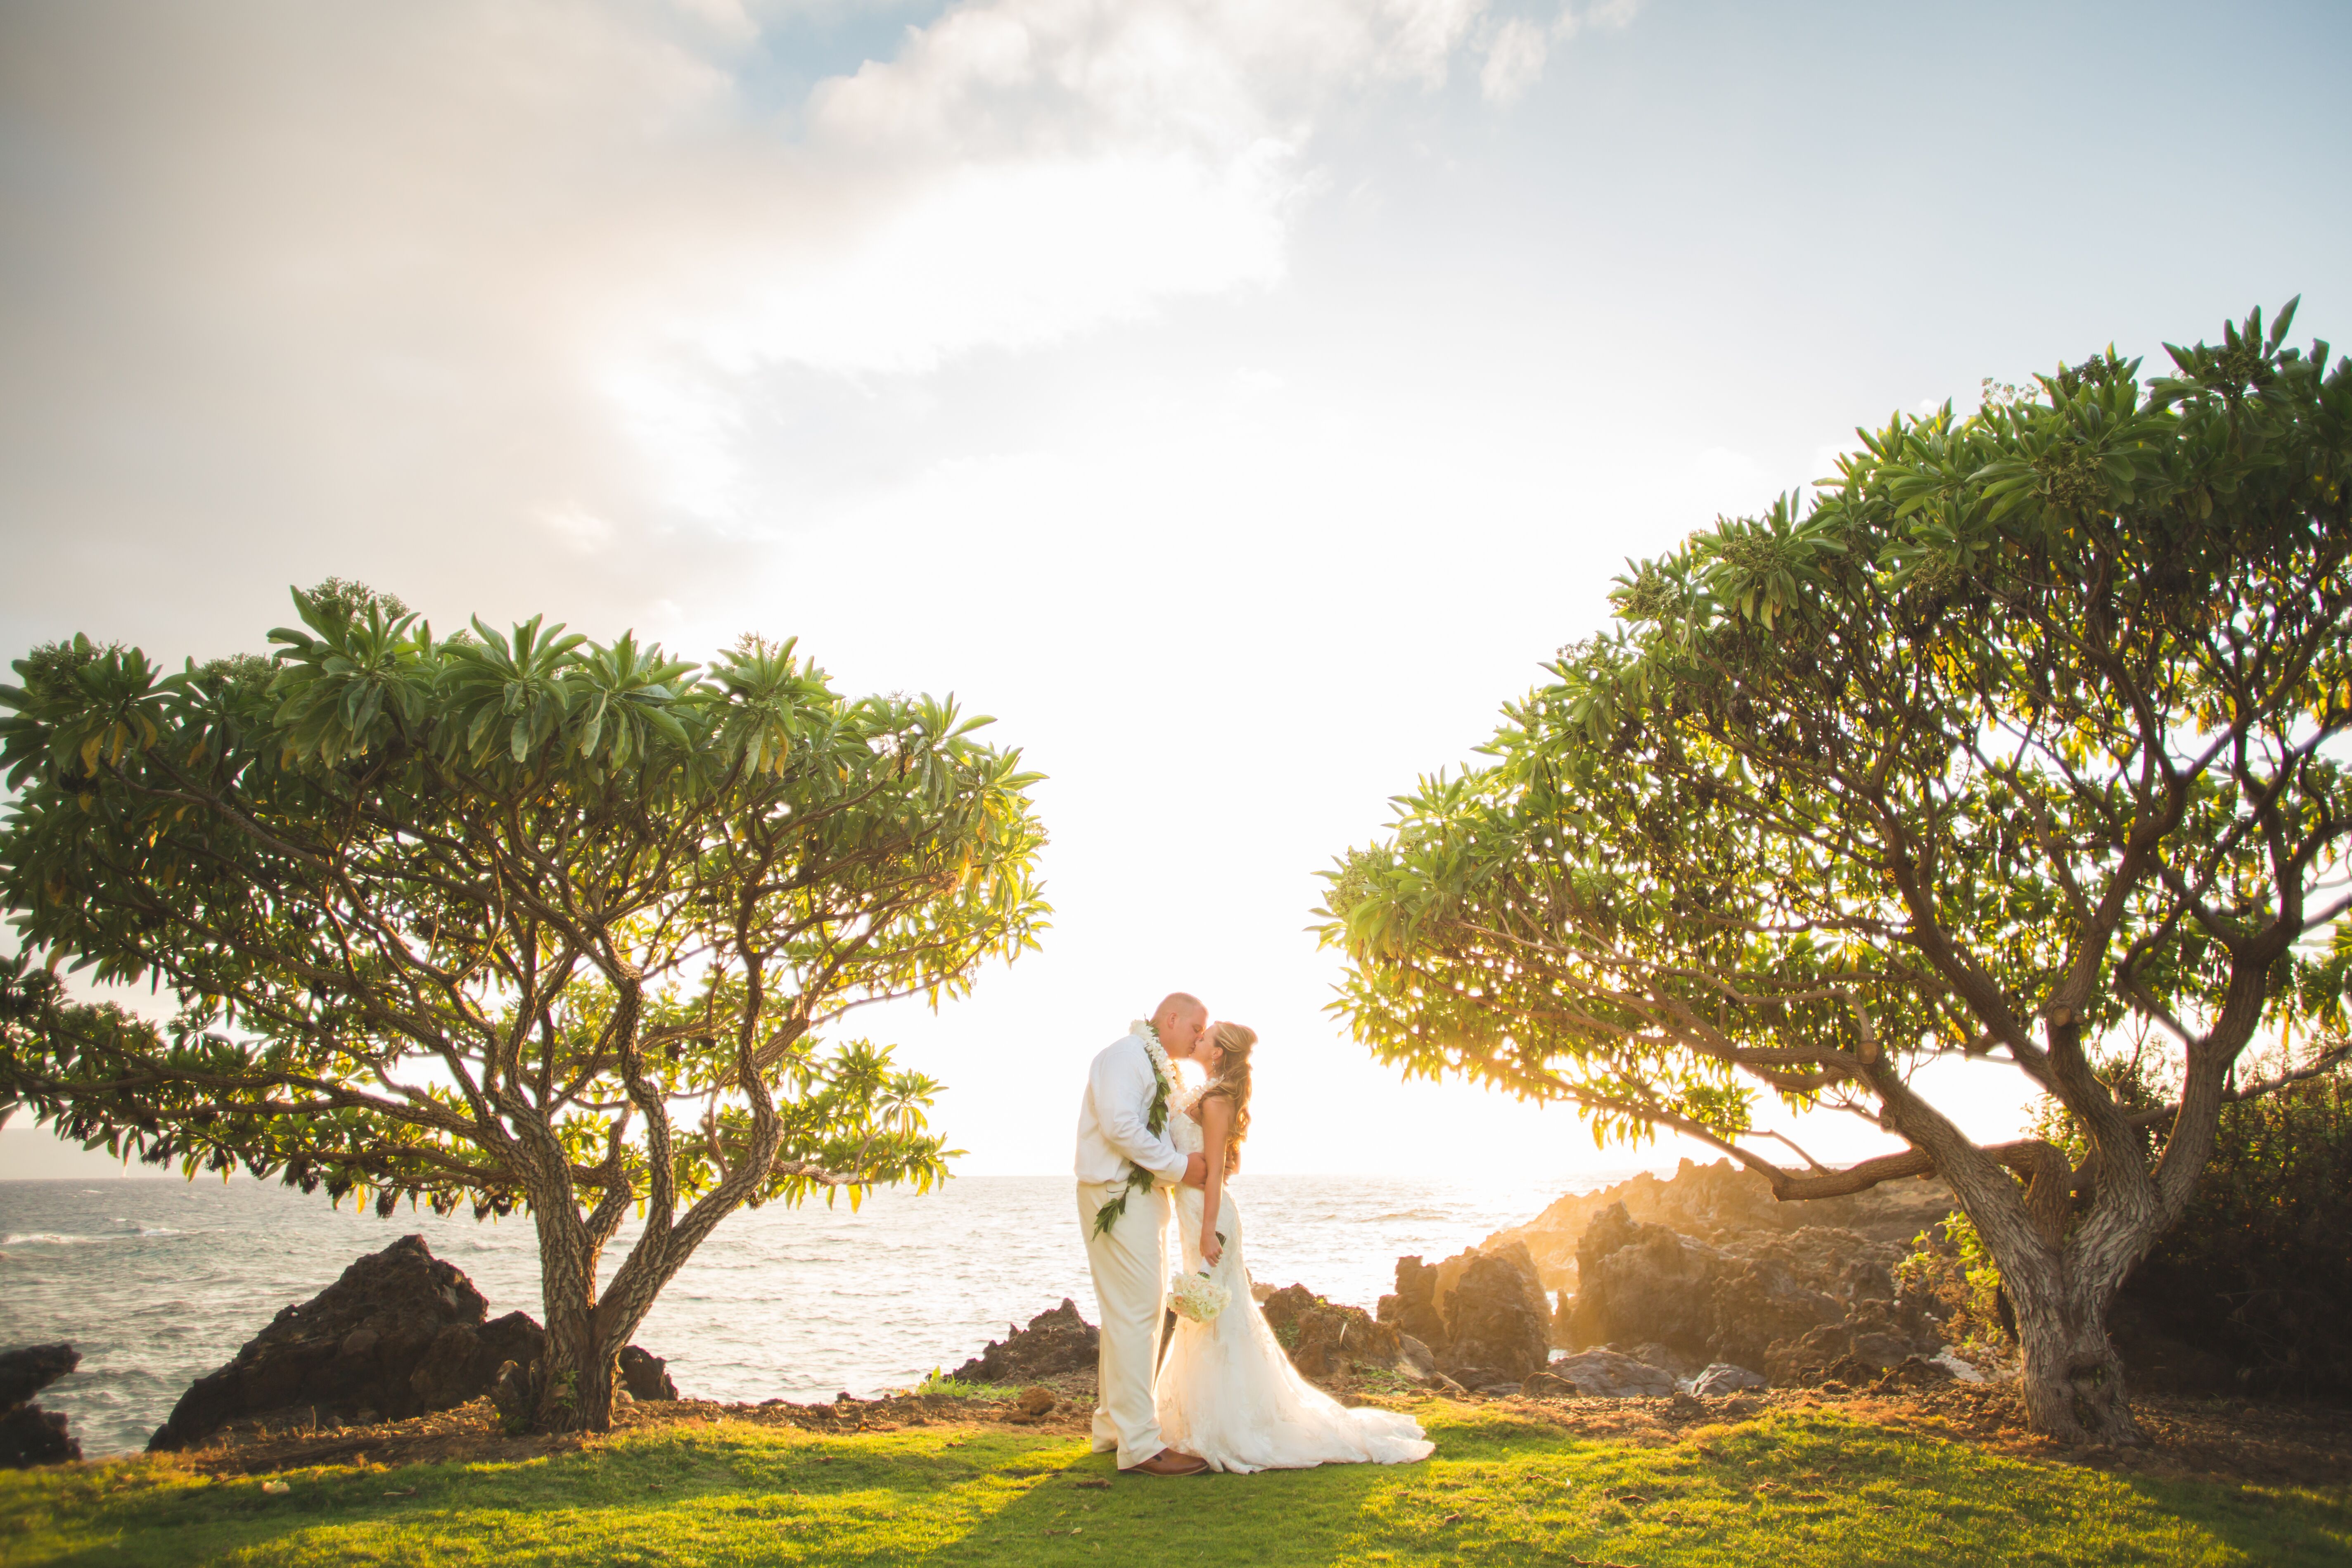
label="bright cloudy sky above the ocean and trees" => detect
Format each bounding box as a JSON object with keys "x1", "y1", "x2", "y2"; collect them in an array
[{"x1": 0, "y1": 0, "x2": 2352, "y2": 1180}]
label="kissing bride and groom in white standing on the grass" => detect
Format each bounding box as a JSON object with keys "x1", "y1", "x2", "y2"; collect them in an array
[{"x1": 1077, "y1": 992, "x2": 1435, "y2": 1476}]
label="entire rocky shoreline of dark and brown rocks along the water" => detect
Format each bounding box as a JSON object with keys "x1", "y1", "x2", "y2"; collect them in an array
[{"x1": 0, "y1": 1161, "x2": 2305, "y2": 1465}]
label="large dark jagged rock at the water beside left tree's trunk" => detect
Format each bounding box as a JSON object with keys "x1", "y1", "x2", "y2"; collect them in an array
[{"x1": 148, "y1": 1236, "x2": 675, "y2": 1453}]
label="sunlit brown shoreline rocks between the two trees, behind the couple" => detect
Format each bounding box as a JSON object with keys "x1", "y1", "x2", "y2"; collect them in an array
[{"x1": 953, "y1": 1161, "x2": 1985, "y2": 1399}]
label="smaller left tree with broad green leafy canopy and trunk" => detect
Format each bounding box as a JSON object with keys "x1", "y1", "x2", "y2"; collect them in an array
[{"x1": 0, "y1": 583, "x2": 1047, "y2": 1429}]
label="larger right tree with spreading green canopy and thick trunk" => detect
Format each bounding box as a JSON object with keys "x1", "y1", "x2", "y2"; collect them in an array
[{"x1": 1324, "y1": 306, "x2": 2352, "y2": 1441}]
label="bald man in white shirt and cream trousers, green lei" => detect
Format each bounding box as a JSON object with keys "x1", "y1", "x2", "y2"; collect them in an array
[{"x1": 1077, "y1": 992, "x2": 1209, "y2": 1476}]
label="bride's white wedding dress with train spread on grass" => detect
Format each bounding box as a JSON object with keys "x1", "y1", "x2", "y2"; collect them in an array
[{"x1": 1155, "y1": 1091, "x2": 1437, "y2": 1474}]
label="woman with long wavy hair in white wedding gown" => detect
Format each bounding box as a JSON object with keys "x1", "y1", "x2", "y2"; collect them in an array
[{"x1": 1155, "y1": 1022, "x2": 1435, "y2": 1474}]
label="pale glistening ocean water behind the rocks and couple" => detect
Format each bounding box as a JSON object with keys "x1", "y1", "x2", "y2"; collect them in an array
[{"x1": 0, "y1": 1171, "x2": 1632, "y2": 1455}]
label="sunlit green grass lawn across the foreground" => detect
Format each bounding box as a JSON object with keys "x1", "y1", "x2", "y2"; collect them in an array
[{"x1": 0, "y1": 1401, "x2": 2352, "y2": 1568}]
